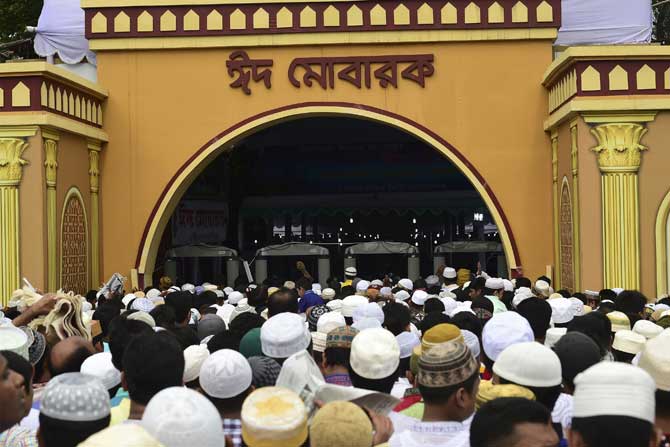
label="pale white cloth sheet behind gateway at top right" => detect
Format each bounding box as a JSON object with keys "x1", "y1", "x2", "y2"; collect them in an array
[{"x1": 555, "y1": 0, "x2": 652, "y2": 46}]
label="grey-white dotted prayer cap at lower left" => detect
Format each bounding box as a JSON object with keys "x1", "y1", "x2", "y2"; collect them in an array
[{"x1": 40, "y1": 372, "x2": 110, "y2": 422}]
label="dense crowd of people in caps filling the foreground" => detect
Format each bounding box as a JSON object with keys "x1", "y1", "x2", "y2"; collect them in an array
[{"x1": 0, "y1": 267, "x2": 670, "y2": 447}]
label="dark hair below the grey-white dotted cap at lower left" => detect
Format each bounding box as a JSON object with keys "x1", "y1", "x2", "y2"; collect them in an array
[{"x1": 38, "y1": 412, "x2": 111, "y2": 447}]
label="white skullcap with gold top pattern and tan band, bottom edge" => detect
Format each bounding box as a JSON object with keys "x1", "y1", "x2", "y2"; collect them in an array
[{"x1": 241, "y1": 386, "x2": 307, "y2": 447}]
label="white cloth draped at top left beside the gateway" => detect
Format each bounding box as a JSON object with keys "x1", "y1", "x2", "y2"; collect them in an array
[{"x1": 35, "y1": 0, "x2": 96, "y2": 65}]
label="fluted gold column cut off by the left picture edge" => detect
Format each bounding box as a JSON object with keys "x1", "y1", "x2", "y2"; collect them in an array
[{"x1": 0, "y1": 136, "x2": 30, "y2": 305}]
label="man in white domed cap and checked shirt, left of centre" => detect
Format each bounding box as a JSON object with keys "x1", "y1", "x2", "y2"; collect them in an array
[{"x1": 200, "y1": 349, "x2": 254, "y2": 447}]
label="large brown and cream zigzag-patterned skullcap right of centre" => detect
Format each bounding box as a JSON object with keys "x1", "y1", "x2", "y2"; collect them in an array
[{"x1": 417, "y1": 341, "x2": 479, "y2": 388}]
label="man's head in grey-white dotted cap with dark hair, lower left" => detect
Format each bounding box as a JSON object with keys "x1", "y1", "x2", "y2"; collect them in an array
[{"x1": 38, "y1": 373, "x2": 110, "y2": 447}]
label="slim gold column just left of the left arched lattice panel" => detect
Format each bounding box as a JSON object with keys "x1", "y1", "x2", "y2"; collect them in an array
[{"x1": 42, "y1": 129, "x2": 59, "y2": 292}]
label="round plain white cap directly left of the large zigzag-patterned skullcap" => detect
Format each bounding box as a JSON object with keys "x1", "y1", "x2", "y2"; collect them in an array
[{"x1": 349, "y1": 328, "x2": 400, "y2": 379}]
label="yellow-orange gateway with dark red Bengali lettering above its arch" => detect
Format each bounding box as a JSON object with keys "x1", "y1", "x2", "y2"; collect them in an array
[{"x1": 0, "y1": 0, "x2": 670, "y2": 303}]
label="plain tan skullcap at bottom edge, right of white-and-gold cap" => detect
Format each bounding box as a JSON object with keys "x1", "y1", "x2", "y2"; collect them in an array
[{"x1": 309, "y1": 401, "x2": 373, "y2": 447}]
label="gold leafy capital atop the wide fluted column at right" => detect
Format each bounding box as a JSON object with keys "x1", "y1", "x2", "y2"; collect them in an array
[{"x1": 591, "y1": 123, "x2": 647, "y2": 173}]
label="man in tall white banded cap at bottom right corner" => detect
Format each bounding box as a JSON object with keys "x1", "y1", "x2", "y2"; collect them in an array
[{"x1": 568, "y1": 362, "x2": 658, "y2": 447}]
